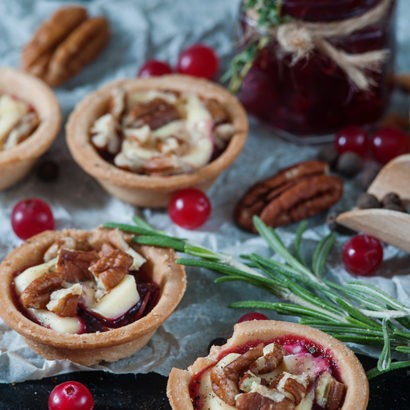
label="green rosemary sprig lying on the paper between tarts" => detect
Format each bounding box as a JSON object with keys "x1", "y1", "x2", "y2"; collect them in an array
[{"x1": 104, "y1": 217, "x2": 410, "y2": 378}]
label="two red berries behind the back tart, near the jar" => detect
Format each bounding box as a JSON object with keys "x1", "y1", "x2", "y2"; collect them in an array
[{"x1": 138, "y1": 44, "x2": 219, "y2": 80}]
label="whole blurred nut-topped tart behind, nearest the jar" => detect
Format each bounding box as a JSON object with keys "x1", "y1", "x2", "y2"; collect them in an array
[{"x1": 67, "y1": 75, "x2": 248, "y2": 207}]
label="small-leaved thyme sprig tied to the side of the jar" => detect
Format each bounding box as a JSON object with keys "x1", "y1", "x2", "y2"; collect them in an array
[{"x1": 222, "y1": 0, "x2": 290, "y2": 93}]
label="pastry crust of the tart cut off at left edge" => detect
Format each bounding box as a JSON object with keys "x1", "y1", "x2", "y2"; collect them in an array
[{"x1": 0, "y1": 68, "x2": 61, "y2": 190}]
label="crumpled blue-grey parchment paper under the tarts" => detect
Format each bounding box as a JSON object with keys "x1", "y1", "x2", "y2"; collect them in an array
[{"x1": 0, "y1": 0, "x2": 410, "y2": 383}]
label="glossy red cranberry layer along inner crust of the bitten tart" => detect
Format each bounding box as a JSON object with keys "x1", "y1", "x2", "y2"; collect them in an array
[{"x1": 188, "y1": 335, "x2": 341, "y2": 410}]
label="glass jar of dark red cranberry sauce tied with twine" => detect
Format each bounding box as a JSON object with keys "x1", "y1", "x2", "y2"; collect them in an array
[{"x1": 239, "y1": 0, "x2": 395, "y2": 142}]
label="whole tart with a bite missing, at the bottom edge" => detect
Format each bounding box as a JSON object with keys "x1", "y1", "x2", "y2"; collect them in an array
[{"x1": 167, "y1": 320, "x2": 369, "y2": 410}]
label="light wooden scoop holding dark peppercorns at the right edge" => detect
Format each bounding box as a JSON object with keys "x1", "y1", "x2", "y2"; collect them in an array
[{"x1": 336, "y1": 154, "x2": 410, "y2": 252}]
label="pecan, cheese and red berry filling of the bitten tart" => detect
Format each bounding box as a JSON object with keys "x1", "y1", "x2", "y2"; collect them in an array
[{"x1": 189, "y1": 335, "x2": 346, "y2": 410}]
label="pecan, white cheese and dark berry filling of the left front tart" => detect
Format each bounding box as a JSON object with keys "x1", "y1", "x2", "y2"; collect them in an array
[{"x1": 13, "y1": 230, "x2": 159, "y2": 334}]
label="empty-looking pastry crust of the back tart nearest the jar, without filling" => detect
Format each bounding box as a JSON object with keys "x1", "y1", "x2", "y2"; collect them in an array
[{"x1": 66, "y1": 75, "x2": 248, "y2": 207}]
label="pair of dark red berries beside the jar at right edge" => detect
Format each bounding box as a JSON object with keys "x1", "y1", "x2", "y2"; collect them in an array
[{"x1": 335, "y1": 127, "x2": 410, "y2": 164}]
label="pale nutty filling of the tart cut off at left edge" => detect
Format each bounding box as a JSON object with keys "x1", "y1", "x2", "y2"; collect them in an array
[{"x1": 0, "y1": 93, "x2": 40, "y2": 151}]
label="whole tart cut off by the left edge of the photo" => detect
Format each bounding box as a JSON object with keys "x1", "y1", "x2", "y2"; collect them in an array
[{"x1": 0, "y1": 68, "x2": 61, "y2": 190}]
